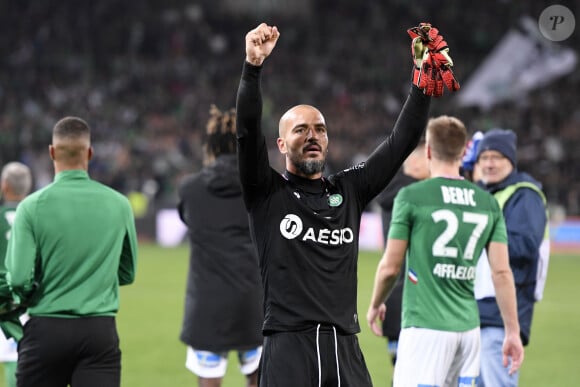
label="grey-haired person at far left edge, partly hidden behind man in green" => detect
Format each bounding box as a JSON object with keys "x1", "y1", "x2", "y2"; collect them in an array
[{"x1": 0, "y1": 161, "x2": 32, "y2": 387}]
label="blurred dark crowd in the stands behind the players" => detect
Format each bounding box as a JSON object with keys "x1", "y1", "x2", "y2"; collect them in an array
[{"x1": 0, "y1": 0, "x2": 580, "y2": 246}]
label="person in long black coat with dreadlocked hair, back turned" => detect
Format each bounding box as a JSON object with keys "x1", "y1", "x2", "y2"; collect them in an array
[{"x1": 178, "y1": 105, "x2": 264, "y2": 387}]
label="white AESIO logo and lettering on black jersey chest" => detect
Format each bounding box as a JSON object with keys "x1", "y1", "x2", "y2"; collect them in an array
[{"x1": 280, "y1": 214, "x2": 354, "y2": 246}]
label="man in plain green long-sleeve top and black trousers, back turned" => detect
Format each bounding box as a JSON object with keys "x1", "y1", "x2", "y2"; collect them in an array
[{"x1": 6, "y1": 117, "x2": 137, "y2": 387}]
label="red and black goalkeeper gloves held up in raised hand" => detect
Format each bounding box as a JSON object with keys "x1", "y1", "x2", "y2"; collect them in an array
[{"x1": 407, "y1": 23, "x2": 460, "y2": 97}]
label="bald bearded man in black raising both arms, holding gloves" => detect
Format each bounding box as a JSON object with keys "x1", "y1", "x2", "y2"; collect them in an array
[{"x1": 236, "y1": 23, "x2": 458, "y2": 387}]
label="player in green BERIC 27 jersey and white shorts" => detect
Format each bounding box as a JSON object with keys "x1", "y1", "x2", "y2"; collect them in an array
[{"x1": 367, "y1": 116, "x2": 524, "y2": 387}]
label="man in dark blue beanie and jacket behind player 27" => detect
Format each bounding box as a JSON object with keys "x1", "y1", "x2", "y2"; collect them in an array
[{"x1": 475, "y1": 129, "x2": 548, "y2": 387}]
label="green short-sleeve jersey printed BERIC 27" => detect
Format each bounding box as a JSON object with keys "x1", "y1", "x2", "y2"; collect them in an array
[{"x1": 389, "y1": 177, "x2": 507, "y2": 332}]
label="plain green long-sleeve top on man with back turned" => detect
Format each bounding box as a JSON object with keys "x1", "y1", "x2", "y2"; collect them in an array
[{"x1": 6, "y1": 170, "x2": 137, "y2": 318}]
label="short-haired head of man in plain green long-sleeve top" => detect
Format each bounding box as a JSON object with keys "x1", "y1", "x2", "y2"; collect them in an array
[{"x1": 49, "y1": 117, "x2": 92, "y2": 172}]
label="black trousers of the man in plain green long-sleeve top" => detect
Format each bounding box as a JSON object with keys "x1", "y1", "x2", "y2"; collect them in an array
[{"x1": 16, "y1": 317, "x2": 121, "y2": 387}]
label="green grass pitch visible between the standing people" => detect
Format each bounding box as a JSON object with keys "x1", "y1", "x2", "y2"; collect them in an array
[{"x1": 0, "y1": 244, "x2": 580, "y2": 387}]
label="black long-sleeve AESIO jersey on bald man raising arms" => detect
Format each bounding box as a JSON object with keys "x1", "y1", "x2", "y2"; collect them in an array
[{"x1": 236, "y1": 62, "x2": 430, "y2": 335}]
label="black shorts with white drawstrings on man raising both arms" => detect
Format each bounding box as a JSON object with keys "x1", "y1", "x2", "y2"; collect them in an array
[{"x1": 258, "y1": 326, "x2": 372, "y2": 387}]
